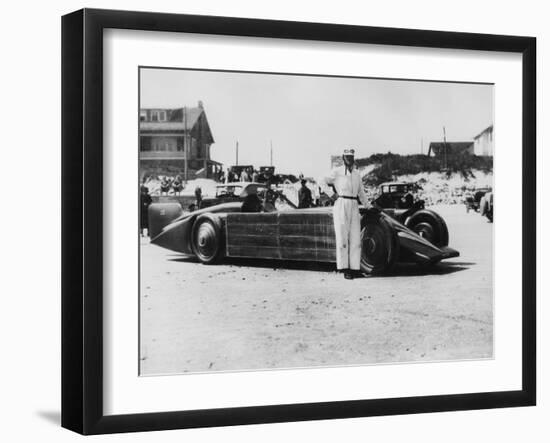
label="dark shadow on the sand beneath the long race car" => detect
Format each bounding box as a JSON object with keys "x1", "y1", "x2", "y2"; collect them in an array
[{"x1": 168, "y1": 254, "x2": 475, "y2": 278}]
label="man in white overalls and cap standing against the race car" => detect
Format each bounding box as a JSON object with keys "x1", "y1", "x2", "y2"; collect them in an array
[{"x1": 326, "y1": 149, "x2": 370, "y2": 279}]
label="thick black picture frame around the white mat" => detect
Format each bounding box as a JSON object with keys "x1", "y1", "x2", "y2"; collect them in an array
[{"x1": 62, "y1": 9, "x2": 536, "y2": 434}]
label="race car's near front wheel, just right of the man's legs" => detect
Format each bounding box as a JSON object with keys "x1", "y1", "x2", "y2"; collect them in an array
[{"x1": 361, "y1": 216, "x2": 399, "y2": 274}]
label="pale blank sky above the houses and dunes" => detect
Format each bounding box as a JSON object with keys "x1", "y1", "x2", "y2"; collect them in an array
[{"x1": 140, "y1": 69, "x2": 493, "y2": 177}]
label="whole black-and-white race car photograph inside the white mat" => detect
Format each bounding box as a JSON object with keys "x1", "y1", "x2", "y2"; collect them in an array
[{"x1": 136, "y1": 66, "x2": 498, "y2": 376}]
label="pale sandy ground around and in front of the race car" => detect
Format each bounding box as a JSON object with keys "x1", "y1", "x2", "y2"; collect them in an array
[{"x1": 140, "y1": 205, "x2": 493, "y2": 375}]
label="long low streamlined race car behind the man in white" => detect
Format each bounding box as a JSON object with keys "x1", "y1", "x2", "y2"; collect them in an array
[{"x1": 149, "y1": 193, "x2": 459, "y2": 274}]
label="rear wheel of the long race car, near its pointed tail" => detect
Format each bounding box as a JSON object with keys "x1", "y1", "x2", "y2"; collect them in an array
[{"x1": 191, "y1": 216, "x2": 223, "y2": 264}]
